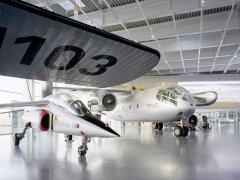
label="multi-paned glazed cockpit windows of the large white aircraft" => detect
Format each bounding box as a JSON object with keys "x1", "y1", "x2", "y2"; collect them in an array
[{"x1": 156, "y1": 86, "x2": 194, "y2": 106}]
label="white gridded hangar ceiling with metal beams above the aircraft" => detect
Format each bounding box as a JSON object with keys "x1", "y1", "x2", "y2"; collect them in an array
[{"x1": 26, "y1": 0, "x2": 240, "y2": 75}]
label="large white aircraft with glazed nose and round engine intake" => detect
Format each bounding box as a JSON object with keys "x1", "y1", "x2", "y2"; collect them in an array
[{"x1": 53, "y1": 86, "x2": 217, "y2": 137}]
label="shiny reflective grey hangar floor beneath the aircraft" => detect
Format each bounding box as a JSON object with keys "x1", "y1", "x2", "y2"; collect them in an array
[{"x1": 0, "y1": 123, "x2": 240, "y2": 180}]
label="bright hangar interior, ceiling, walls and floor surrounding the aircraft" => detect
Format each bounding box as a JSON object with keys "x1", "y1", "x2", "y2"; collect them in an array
[{"x1": 0, "y1": 0, "x2": 240, "y2": 179}]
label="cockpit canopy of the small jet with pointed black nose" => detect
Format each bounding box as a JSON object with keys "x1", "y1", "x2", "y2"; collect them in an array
[{"x1": 49, "y1": 93, "x2": 91, "y2": 116}]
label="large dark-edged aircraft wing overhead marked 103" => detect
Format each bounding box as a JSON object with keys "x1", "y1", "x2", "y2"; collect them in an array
[{"x1": 0, "y1": 0, "x2": 160, "y2": 87}]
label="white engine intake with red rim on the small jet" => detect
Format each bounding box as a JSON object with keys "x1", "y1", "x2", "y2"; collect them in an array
[{"x1": 22, "y1": 109, "x2": 50, "y2": 131}]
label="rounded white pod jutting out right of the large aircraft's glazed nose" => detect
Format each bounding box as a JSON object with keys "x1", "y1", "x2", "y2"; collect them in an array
[{"x1": 192, "y1": 91, "x2": 218, "y2": 106}]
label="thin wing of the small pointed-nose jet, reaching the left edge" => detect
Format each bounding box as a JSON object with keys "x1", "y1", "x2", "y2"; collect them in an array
[{"x1": 0, "y1": 100, "x2": 49, "y2": 108}]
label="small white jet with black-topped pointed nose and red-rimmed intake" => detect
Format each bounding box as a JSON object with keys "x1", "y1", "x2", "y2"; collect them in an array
[{"x1": 0, "y1": 93, "x2": 119, "y2": 156}]
